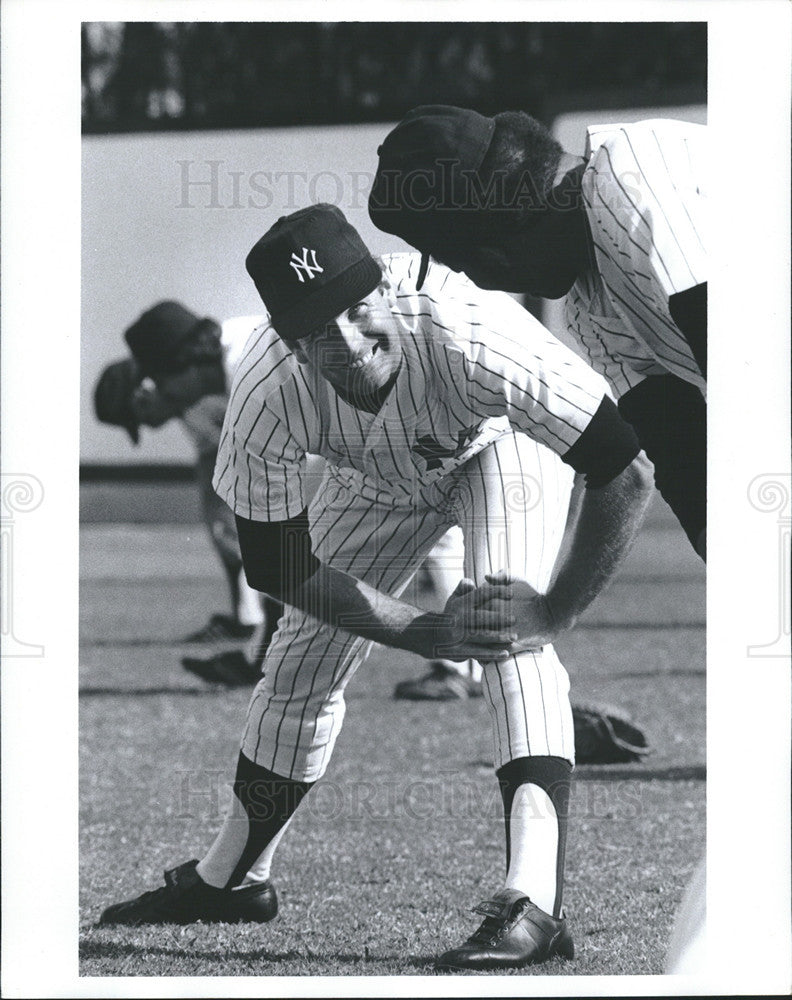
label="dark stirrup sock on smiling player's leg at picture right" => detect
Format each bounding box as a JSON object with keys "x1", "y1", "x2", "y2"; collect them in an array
[{"x1": 496, "y1": 757, "x2": 572, "y2": 917}]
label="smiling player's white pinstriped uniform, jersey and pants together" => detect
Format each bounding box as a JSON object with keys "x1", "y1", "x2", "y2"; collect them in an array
[{"x1": 214, "y1": 254, "x2": 606, "y2": 781}]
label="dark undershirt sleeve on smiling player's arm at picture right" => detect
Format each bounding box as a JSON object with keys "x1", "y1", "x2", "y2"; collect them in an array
[{"x1": 561, "y1": 396, "x2": 641, "y2": 489}]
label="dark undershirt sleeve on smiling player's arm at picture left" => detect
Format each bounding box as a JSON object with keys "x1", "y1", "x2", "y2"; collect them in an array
[{"x1": 236, "y1": 509, "x2": 319, "y2": 601}]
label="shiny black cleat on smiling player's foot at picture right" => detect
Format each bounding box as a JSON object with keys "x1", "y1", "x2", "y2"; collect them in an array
[{"x1": 435, "y1": 889, "x2": 575, "y2": 972}]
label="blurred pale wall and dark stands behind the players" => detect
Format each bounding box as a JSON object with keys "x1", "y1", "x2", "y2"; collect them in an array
[{"x1": 81, "y1": 22, "x2": 707, "y2": 521}]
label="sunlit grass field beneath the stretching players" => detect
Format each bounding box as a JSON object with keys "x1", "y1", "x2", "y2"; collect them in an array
[{"x1": 80, "y1": 502, "x2": 705, "y2": 980}]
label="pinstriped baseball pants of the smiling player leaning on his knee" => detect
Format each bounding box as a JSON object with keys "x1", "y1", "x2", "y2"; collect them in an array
[{"x1": 242, "y1": 433, "x2": 574, "y2": 781}]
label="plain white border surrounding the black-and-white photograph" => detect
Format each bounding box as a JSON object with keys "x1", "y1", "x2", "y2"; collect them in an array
[{"x1": 0, "y1": 0, "x2": 792, "y2": 997}]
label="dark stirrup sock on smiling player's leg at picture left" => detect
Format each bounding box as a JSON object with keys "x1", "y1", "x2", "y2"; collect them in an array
[{"x1": 225, "y1": 753, "x2": 314, "y2": 889}]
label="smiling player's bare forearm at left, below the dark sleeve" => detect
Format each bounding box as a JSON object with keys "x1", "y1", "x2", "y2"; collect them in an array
[{"x1": 284, "y1": 563, "x2": 448, "y2": 659}]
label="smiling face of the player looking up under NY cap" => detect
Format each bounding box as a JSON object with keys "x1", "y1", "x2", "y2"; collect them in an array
[{"x1": 295, "y1": 286, "x2": 402, "y2": 403}]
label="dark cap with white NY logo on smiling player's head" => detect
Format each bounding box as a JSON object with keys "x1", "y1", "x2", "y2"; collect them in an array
[{"x1": 245, "y1": 204, "x2": 382, "y2": 341}]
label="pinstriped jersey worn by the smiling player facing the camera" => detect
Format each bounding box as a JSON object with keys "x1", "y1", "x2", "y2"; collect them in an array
[{"x1": 214, "y1": 254, "x2": 607, "y2": 521}]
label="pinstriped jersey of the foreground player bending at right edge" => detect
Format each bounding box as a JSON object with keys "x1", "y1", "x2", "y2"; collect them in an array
[{"x1": 565, "y1": 119, "x2": 707, "y2": 397}]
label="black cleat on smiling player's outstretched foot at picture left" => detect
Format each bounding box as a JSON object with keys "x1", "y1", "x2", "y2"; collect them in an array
[{"x1": 99, "y1": 859, "x2": 278, "y2": 927}]
